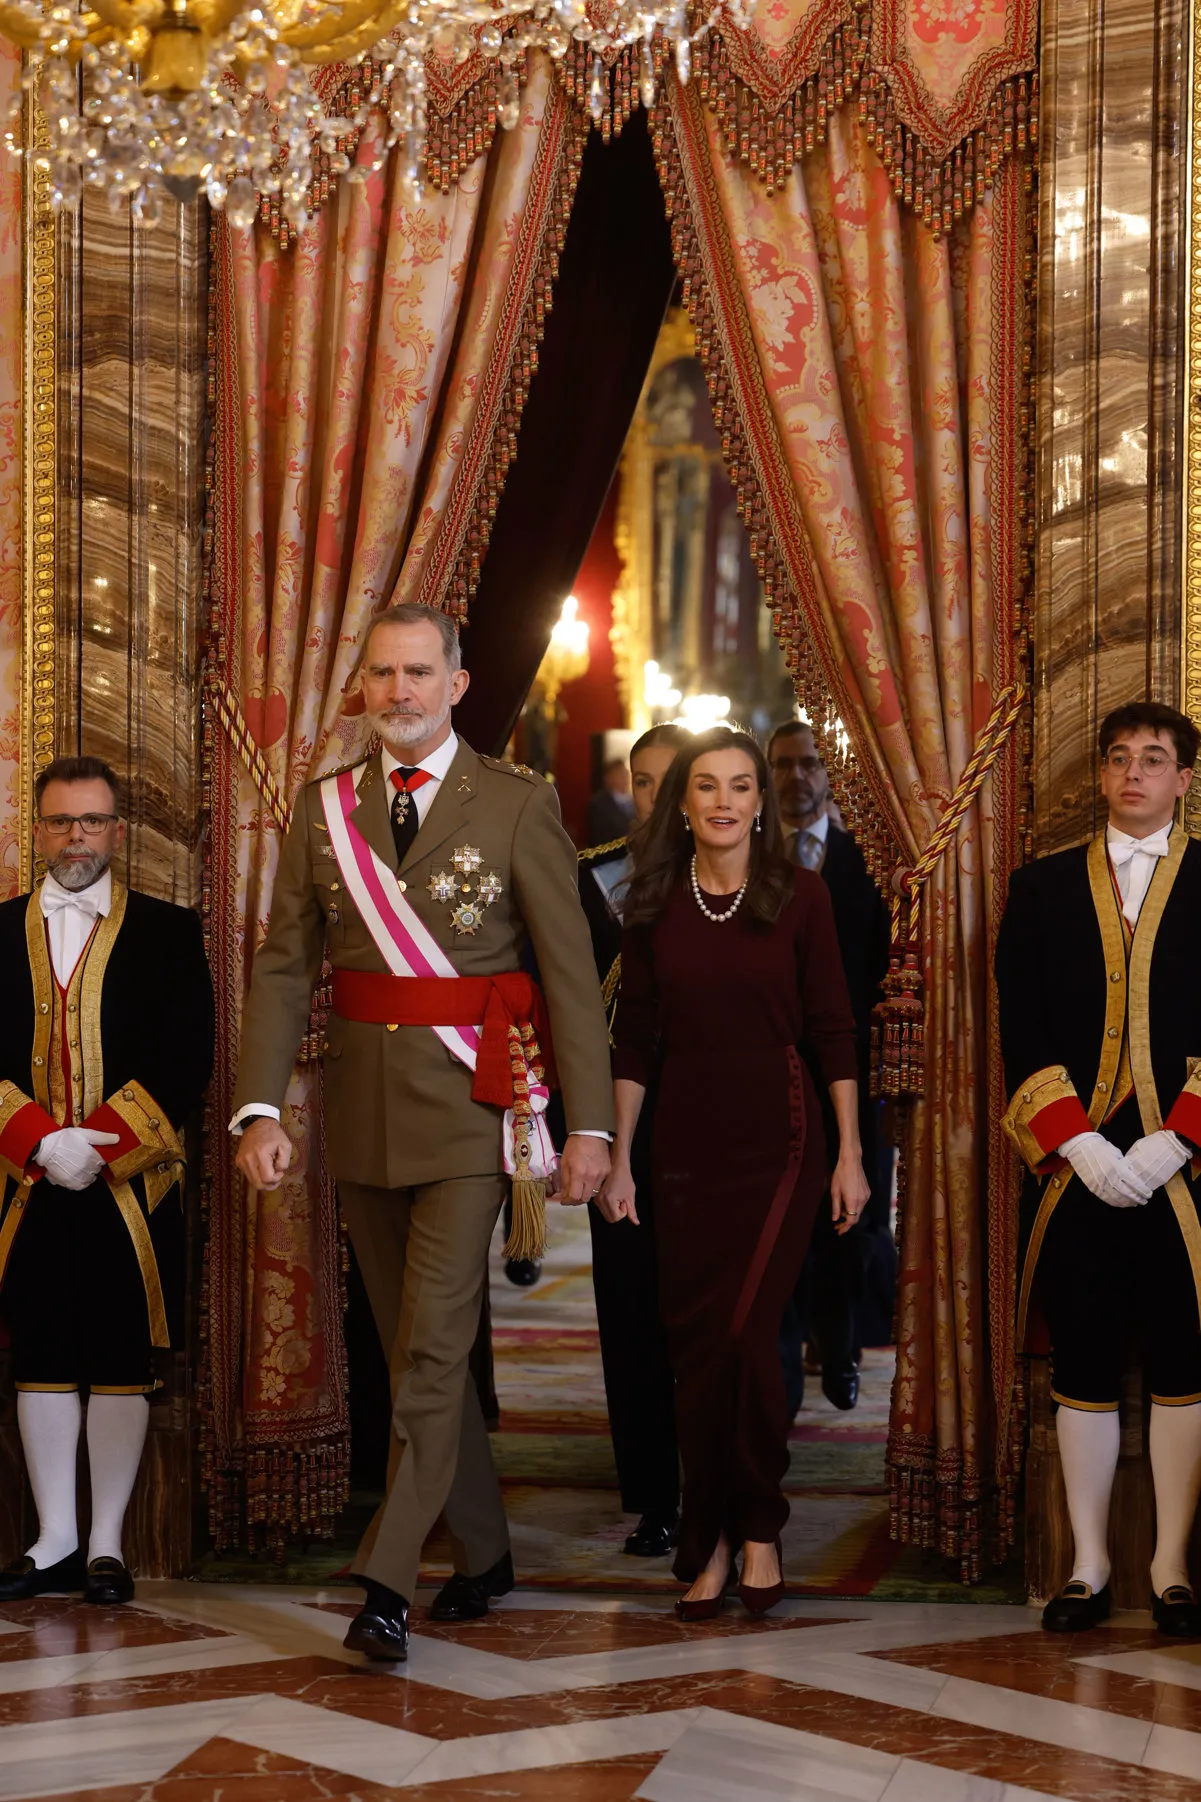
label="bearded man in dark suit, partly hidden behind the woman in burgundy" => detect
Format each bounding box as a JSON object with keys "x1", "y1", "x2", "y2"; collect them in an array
[{"x1": 766, "y1": 719, "x2": 891, "y2": 1418}]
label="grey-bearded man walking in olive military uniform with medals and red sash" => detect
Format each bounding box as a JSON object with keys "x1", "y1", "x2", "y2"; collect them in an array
[{"x1": 231, "y1": 605, "x2": 613, "y2": 1660}]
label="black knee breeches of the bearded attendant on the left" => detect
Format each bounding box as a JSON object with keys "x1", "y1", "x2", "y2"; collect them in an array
[{"x1": 0, "y1": 1180, "x2": 184, "y2": 1395}]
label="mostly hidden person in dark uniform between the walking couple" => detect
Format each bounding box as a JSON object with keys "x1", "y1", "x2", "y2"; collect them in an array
[{"x1": 579, "y1": 724, "x2": 678, "y2": 1559}]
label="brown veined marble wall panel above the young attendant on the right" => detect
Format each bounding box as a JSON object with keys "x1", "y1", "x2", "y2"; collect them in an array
[{"x1": 1035, "y1": 0, "x2": 1188, "y2": 854}]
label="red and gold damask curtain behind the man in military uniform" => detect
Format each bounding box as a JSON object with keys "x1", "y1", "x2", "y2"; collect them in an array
[{"x1": 204, "y1": 68, "x2": 582, "y2": 1544}]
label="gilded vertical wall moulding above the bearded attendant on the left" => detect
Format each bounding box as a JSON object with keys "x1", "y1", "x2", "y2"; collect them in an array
[{"x1": 20, "y1": 82, "x2": 58, "y2": 888}]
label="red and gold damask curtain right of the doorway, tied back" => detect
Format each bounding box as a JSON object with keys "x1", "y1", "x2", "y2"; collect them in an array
[{"x1": 662, "y1": 38, "x2": 1028, "y2": 1579}]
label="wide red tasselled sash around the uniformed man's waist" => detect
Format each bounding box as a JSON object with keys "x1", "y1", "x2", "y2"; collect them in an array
[{"x1": 324, "y1": 969, "x2": 557, "y2": 1108}]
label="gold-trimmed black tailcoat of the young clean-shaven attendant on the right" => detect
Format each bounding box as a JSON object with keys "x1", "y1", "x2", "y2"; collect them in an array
[{"x1": 995, "y1": 825, "x2": 1201, "y2": 1333}]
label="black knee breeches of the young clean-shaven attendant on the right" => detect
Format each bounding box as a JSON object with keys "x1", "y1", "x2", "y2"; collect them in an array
[{"x1": 1039, "y1": 1179, "x2": 1201, "y2": 1409}]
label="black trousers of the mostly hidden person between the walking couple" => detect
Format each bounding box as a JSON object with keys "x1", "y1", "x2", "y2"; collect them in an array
[{"x1": 588, "y1": 1096, "x2": 680, "y2": 1515}]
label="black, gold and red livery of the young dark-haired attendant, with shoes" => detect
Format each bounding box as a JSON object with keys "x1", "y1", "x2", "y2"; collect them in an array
[{"x1": 995, "y1": 825, "x2": 1201, "y2": 1633}]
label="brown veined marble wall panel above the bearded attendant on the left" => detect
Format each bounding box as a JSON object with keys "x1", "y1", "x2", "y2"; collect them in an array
[{"x1": 56, "y1": 196, "x2": 207, "y2": 905}]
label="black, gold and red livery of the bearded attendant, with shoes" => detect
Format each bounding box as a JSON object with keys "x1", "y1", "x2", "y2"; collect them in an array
[{"x1": 0, "y1": 872, "x2": 213, "y2": 1602}]
